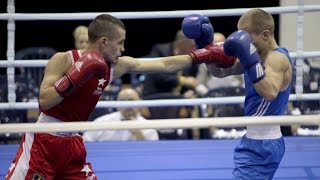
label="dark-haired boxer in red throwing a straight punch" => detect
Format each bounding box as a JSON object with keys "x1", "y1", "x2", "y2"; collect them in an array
[{"x1": 6, "y1": 14, "x2": 235, "y2": 180}]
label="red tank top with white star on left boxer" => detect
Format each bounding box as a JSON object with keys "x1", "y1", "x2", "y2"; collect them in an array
[{"x1": 40, "y1": 50, "x2": 113, "y2": 122}]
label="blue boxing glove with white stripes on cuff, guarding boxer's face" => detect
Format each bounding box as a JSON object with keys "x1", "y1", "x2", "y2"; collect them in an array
[{"x1": 224, "y1": 30, "x2": 265, "y2": 83}]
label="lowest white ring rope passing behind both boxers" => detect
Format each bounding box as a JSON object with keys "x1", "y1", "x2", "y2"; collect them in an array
[{"x1": 0, "y1": 93, "x2": 320, "y2": 110}]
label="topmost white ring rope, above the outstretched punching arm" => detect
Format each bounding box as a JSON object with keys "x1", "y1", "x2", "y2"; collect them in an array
[{"x1": 0, "y1": 5, "x2": 320, "y2": 21}]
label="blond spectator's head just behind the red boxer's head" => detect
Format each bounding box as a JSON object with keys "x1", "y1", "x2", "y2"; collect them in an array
[{"x1": 73, "y1": 26, "x2": 89, "y2": 49}]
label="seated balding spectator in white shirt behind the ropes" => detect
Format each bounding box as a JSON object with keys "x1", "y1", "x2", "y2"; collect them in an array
[{"x1": 83, "y1": 88, "x2": 159, "y2": 142}]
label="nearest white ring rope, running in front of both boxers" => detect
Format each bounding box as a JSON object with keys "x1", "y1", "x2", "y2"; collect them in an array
[{"x1": 0, "y1": 115, "x2": 320, "y2": 133}]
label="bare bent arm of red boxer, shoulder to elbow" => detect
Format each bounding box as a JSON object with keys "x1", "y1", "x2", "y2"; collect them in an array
[{"x1": 39, "y1": 53, "x2": 71, "y2": 110}]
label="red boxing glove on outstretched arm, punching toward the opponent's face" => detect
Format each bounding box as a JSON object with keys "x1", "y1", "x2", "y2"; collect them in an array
[{"x1": 190, "y1": 43, "x2": 237, "y2": 68}]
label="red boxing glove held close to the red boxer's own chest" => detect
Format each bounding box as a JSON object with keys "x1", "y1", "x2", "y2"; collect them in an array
[{"x1": 55, "y1": 51, "x2": 108, "y2": 97}]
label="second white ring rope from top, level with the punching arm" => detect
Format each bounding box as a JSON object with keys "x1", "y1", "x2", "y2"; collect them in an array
[{"x1": 0, "y1": 51, "x2": 320, "y2": 67}]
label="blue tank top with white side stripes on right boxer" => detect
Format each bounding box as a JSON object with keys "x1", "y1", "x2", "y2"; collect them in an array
[{"x1": 244, "y1": 48, "x2": 292, "y2": 116}]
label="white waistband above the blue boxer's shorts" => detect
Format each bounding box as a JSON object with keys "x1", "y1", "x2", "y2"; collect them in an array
[{"x1": 246, "y1": 125, "x2": 282, "y2": 139}]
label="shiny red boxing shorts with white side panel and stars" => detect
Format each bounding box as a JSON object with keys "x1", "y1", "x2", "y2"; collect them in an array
[{"x1": 6, "y1": 133, "x2": 97, "y2": 180}]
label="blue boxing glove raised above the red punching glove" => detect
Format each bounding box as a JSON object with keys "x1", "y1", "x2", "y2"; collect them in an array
[{"x1": 182, "y1": 14, "x2": 214, "y2": 49}]
